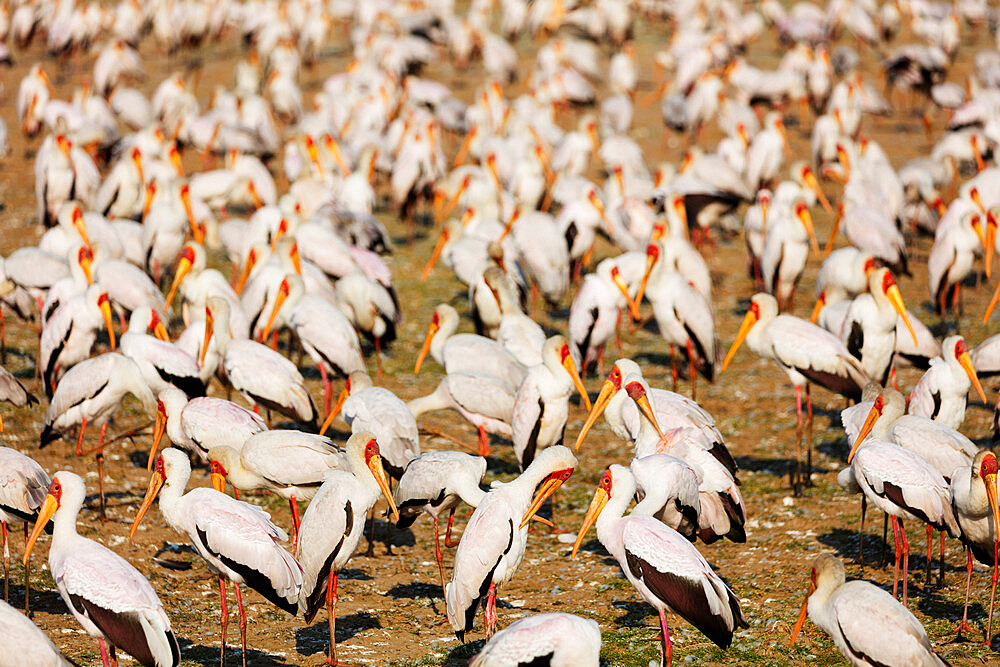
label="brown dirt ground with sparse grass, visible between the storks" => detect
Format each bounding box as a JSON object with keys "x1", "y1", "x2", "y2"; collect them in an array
[{"x1": 0, "y1": 5, "x2": 1000, "y2": 665}]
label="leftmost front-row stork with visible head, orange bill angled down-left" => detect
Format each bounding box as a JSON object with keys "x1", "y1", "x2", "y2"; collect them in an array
[{"x1": 23, "y1": 470, "x2": 181, "y2": 667}]
